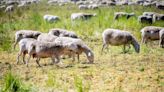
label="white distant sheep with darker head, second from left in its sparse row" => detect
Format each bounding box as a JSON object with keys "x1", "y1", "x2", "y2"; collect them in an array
[{"x1": 71, "y1": 13, "x2": 96, "y2": 20}]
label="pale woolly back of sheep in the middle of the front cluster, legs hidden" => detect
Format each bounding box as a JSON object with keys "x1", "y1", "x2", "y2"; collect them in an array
[{"x1": 37, "y1": 33, "x2": 57, "y2": 42}]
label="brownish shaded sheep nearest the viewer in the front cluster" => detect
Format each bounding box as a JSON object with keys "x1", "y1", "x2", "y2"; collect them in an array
[{"x1": 26, "y1": 41, "x2": 71, "y2": 67}]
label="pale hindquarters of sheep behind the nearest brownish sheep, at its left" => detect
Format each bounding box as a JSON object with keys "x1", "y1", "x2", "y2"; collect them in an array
[{"x1": 17, "y1": 38, "x2": 36, "y2": 64}]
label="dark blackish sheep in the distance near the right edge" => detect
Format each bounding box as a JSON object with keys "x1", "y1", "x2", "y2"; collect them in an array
[{"x1": 138, "y1": 15, "x2": 155, "y2": 24}]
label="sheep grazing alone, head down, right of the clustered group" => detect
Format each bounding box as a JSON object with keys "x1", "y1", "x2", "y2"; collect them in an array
[{"x1": 101, "y1": 28, "x2": 140, "y2": 53}]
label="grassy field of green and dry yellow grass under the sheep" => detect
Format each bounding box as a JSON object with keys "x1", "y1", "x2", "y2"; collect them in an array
[{"x1": 0, "y1": 2, "x2": 164, "y2": 92}]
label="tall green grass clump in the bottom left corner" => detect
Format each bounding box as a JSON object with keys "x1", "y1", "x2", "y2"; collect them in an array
[{"x1": 0, "y1": 71, "x2": 30, "y2": 92}]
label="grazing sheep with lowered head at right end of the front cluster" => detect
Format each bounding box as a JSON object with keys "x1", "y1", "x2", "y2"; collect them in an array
[{"x1": 55, "y1": 37, "x2": 94, "y2": 63}]
